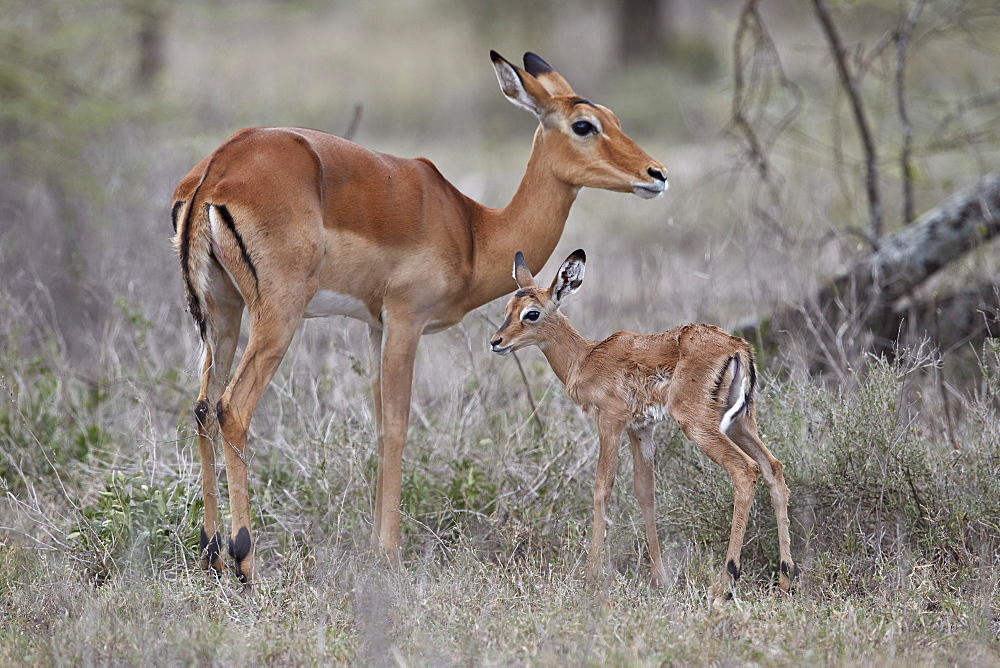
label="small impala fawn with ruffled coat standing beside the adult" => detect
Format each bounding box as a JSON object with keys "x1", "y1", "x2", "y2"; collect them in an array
[{"x1": 490, "y1": 250, "x2": 799, "y2": 598}]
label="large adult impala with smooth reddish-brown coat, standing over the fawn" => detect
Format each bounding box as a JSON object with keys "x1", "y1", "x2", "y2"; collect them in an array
[{"x1": 172, "y1": 51, "x2": 667, "y2": 582}]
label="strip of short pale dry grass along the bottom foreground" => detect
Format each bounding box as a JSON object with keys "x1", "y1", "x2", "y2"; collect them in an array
[{"x1": 0, "y1": 528, "x2": 997, "y2": 665}]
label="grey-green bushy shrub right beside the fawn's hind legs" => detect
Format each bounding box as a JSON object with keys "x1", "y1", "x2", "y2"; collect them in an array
[{"x1": 756, "y1": 359, "x2": 1000, "y2": 581}]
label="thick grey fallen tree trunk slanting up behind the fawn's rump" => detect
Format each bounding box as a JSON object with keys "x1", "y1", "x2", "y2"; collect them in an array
[{"x1": 739, "y1": 171, "x2": 1000, "y2": 370}]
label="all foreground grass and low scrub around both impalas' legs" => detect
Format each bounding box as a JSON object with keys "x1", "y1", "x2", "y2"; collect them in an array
[{"x1": 0, "y1": 312, "x2": 1000, "y2": 665}]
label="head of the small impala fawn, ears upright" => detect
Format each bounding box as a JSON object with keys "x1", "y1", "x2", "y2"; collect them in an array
[{"x1": 490, "y1": 249, "x2": 587, "y2": 355}]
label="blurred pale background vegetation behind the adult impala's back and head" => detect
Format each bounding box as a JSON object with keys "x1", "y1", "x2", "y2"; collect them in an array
[{"x1": 0, "y1": 0, "x2": 1000, "y2": 356}]
